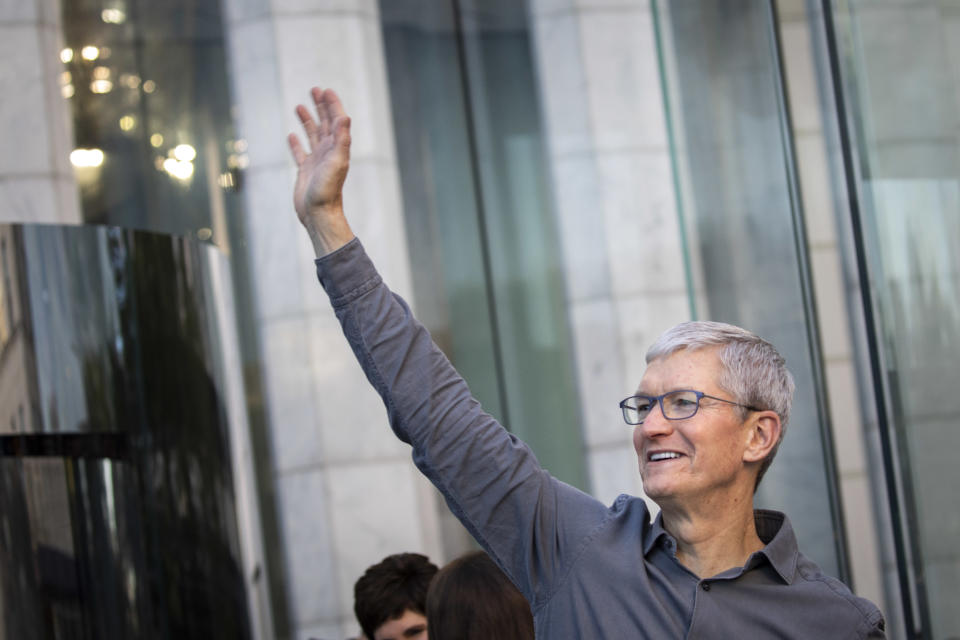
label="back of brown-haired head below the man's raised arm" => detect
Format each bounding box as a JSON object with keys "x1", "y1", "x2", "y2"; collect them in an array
[{"x1": 427, "y1": 551, "x2": 534, "y2": 640}]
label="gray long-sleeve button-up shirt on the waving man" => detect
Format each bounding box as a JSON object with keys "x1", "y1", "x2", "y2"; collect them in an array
[{"x1": 316, "y1": 240, "x2": 884, "y2": 640}]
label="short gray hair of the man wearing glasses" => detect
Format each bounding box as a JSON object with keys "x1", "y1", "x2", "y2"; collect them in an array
[{"x1": 647, "y1": 321, "x2": 795, "y2": 485}]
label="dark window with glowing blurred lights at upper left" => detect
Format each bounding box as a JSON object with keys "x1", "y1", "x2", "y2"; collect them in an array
[{"x1": 61, "y1": 0, "x2": 244, "y2": 247}]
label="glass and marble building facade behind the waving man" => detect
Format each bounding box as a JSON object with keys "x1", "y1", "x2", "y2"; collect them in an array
[{"x1": 0, "y1": 0, "x2": 960, "y2": 639}]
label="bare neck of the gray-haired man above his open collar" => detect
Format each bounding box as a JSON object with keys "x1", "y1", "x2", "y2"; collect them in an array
[{"x1": 661, "y1": 494, "x2": 763, "y2": 578}]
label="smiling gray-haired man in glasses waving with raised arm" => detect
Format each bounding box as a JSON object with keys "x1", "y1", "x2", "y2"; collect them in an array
[{"x1": 289, "y1": 88, "x2": 884, "y2": 640}]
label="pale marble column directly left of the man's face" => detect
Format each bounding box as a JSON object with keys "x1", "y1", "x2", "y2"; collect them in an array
[{"x1": 531, "y1": 0, "x2": 689, "y2": 510}]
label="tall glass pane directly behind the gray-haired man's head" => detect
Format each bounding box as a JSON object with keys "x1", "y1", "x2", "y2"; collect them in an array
[{"x1": 657, "y1": 0, "x2": 842, "y2": 575}]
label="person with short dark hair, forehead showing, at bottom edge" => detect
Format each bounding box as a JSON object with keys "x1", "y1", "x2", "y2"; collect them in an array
[{"x1": 353, "y1": 553, "x2": 437, "y2": 640}]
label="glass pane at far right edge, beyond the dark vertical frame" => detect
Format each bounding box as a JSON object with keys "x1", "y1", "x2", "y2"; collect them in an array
[{"x1": 833, "y1": 0, "x2": 960, "y2": 638}]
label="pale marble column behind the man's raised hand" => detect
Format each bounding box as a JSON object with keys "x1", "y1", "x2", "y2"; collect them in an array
[{"x1": 225, "y1": 0, "x2": 442, "y2": 638}]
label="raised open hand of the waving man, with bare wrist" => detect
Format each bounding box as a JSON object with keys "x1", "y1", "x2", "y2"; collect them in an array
[{"x1": 287, "y1": 87, "x2": 353, "y2": 256}]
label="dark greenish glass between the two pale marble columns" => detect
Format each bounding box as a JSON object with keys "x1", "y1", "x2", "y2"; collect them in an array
[{"x1": 381, "y1": 1, "x2": 586, "y2": 487}]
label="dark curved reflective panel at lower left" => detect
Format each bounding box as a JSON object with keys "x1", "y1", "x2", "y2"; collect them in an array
[{"x1": 0, "y1": 226, "x2": 249, "y2": 638}]
